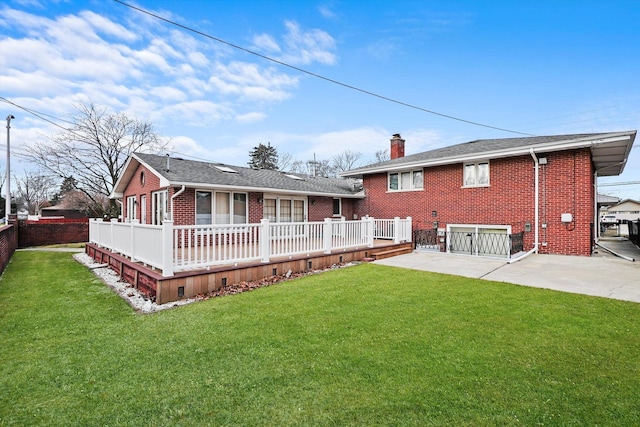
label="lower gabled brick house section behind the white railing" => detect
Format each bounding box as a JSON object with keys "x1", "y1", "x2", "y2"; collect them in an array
[{"x1": 111, "y1": 153, "x2": 364, "y2": 225}]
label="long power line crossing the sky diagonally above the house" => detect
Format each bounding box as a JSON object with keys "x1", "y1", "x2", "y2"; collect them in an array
[{"x1": 114, "y1": 0, "x2": 535, "y2": 136}]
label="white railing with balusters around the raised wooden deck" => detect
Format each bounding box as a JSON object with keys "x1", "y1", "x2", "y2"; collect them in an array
[{"x1": 89, "y1": 217, "x2": 412, "y2": 276}]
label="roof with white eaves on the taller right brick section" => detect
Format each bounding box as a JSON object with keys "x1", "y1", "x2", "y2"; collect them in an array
[{"x1": 341, "y1": 131, "x2": 636, "y2": 177}]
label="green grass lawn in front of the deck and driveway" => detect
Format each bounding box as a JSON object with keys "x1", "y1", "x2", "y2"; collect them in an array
[{"x1": 0, "y1": 252, "x2": 640, "y2": 426}]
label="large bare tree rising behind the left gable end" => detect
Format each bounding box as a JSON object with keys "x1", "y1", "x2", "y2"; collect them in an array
[{"x1": 27, "y1": 102, "x2": 167, "y2": 216}]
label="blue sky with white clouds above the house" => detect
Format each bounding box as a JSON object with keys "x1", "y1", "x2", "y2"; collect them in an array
[{"x1": 0, "y1": 0, "x2": 640, "y2": 200}]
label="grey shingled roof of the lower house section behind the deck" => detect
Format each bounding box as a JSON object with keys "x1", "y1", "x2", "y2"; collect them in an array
[{"x1": 111, "y1": 153, "x2": 364, "y2": 198}]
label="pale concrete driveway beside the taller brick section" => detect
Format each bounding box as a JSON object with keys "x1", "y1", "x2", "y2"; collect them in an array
[{"x1": 374, "y1": 242, "x2": 640, "y2": 302}]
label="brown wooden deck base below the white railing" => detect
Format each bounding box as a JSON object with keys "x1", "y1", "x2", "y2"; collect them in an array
[{"x1": 85, "y1": 240, "x2": 413, "y2": 304}]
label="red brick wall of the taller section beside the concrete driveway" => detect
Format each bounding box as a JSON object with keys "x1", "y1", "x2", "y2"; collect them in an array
[{"x1": 357, "y1": 149, "x2": 593, "y2": 255}]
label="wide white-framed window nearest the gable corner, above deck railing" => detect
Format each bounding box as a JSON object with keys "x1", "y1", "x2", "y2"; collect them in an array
[{"x1": 196, "y1": 191, "x2": 248, "y2": 224}]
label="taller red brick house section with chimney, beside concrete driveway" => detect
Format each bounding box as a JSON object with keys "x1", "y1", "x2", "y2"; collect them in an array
[{"x1": 342, "y1": 131, "x2": 636, "y2": 257}]
